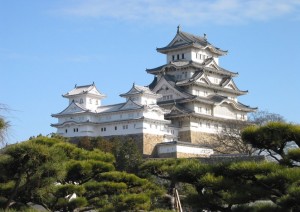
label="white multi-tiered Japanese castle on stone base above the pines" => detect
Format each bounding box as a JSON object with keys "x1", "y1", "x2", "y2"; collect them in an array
[{"x1": 51, "y1": 27, "x2": 256, "y2": 157}]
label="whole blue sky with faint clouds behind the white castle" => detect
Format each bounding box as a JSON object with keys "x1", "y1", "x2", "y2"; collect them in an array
[{"x1": 0, "y1": 0, "x2": 300, "y2": 143}]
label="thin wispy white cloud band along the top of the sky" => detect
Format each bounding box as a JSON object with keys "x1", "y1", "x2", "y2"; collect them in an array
[{"x1": 59, "y1": 0, "x2": 300, "y2": 25}]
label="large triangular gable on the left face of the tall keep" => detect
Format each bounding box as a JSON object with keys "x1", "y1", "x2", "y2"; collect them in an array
[{"x1": 152, "y1": 77, "x2": 188, "y2": 99}]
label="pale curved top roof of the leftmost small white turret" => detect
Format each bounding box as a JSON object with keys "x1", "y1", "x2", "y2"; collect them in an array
[{"x1": 63, "y1": 83, "x2": 105, "y2": 98}]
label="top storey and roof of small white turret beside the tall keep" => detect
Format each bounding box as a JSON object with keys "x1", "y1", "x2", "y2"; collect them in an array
[{"x1": 120, "y1": 83, "x2": 160, "y2": 105}]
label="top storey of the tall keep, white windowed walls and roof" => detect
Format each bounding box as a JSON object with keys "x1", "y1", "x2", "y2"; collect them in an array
[{"x1": 156, "y1": 26, "x2": 227, "y2": 63}]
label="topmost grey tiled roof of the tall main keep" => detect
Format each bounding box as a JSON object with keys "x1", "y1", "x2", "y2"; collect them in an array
[{"x1": 156, "y1": 27, "x2": 227, "y2": 55}]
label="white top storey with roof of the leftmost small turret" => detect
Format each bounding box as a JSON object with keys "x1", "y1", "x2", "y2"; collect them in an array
[{"x1": 63, "y1": 83, "x2": 105, "y2": 111}]
